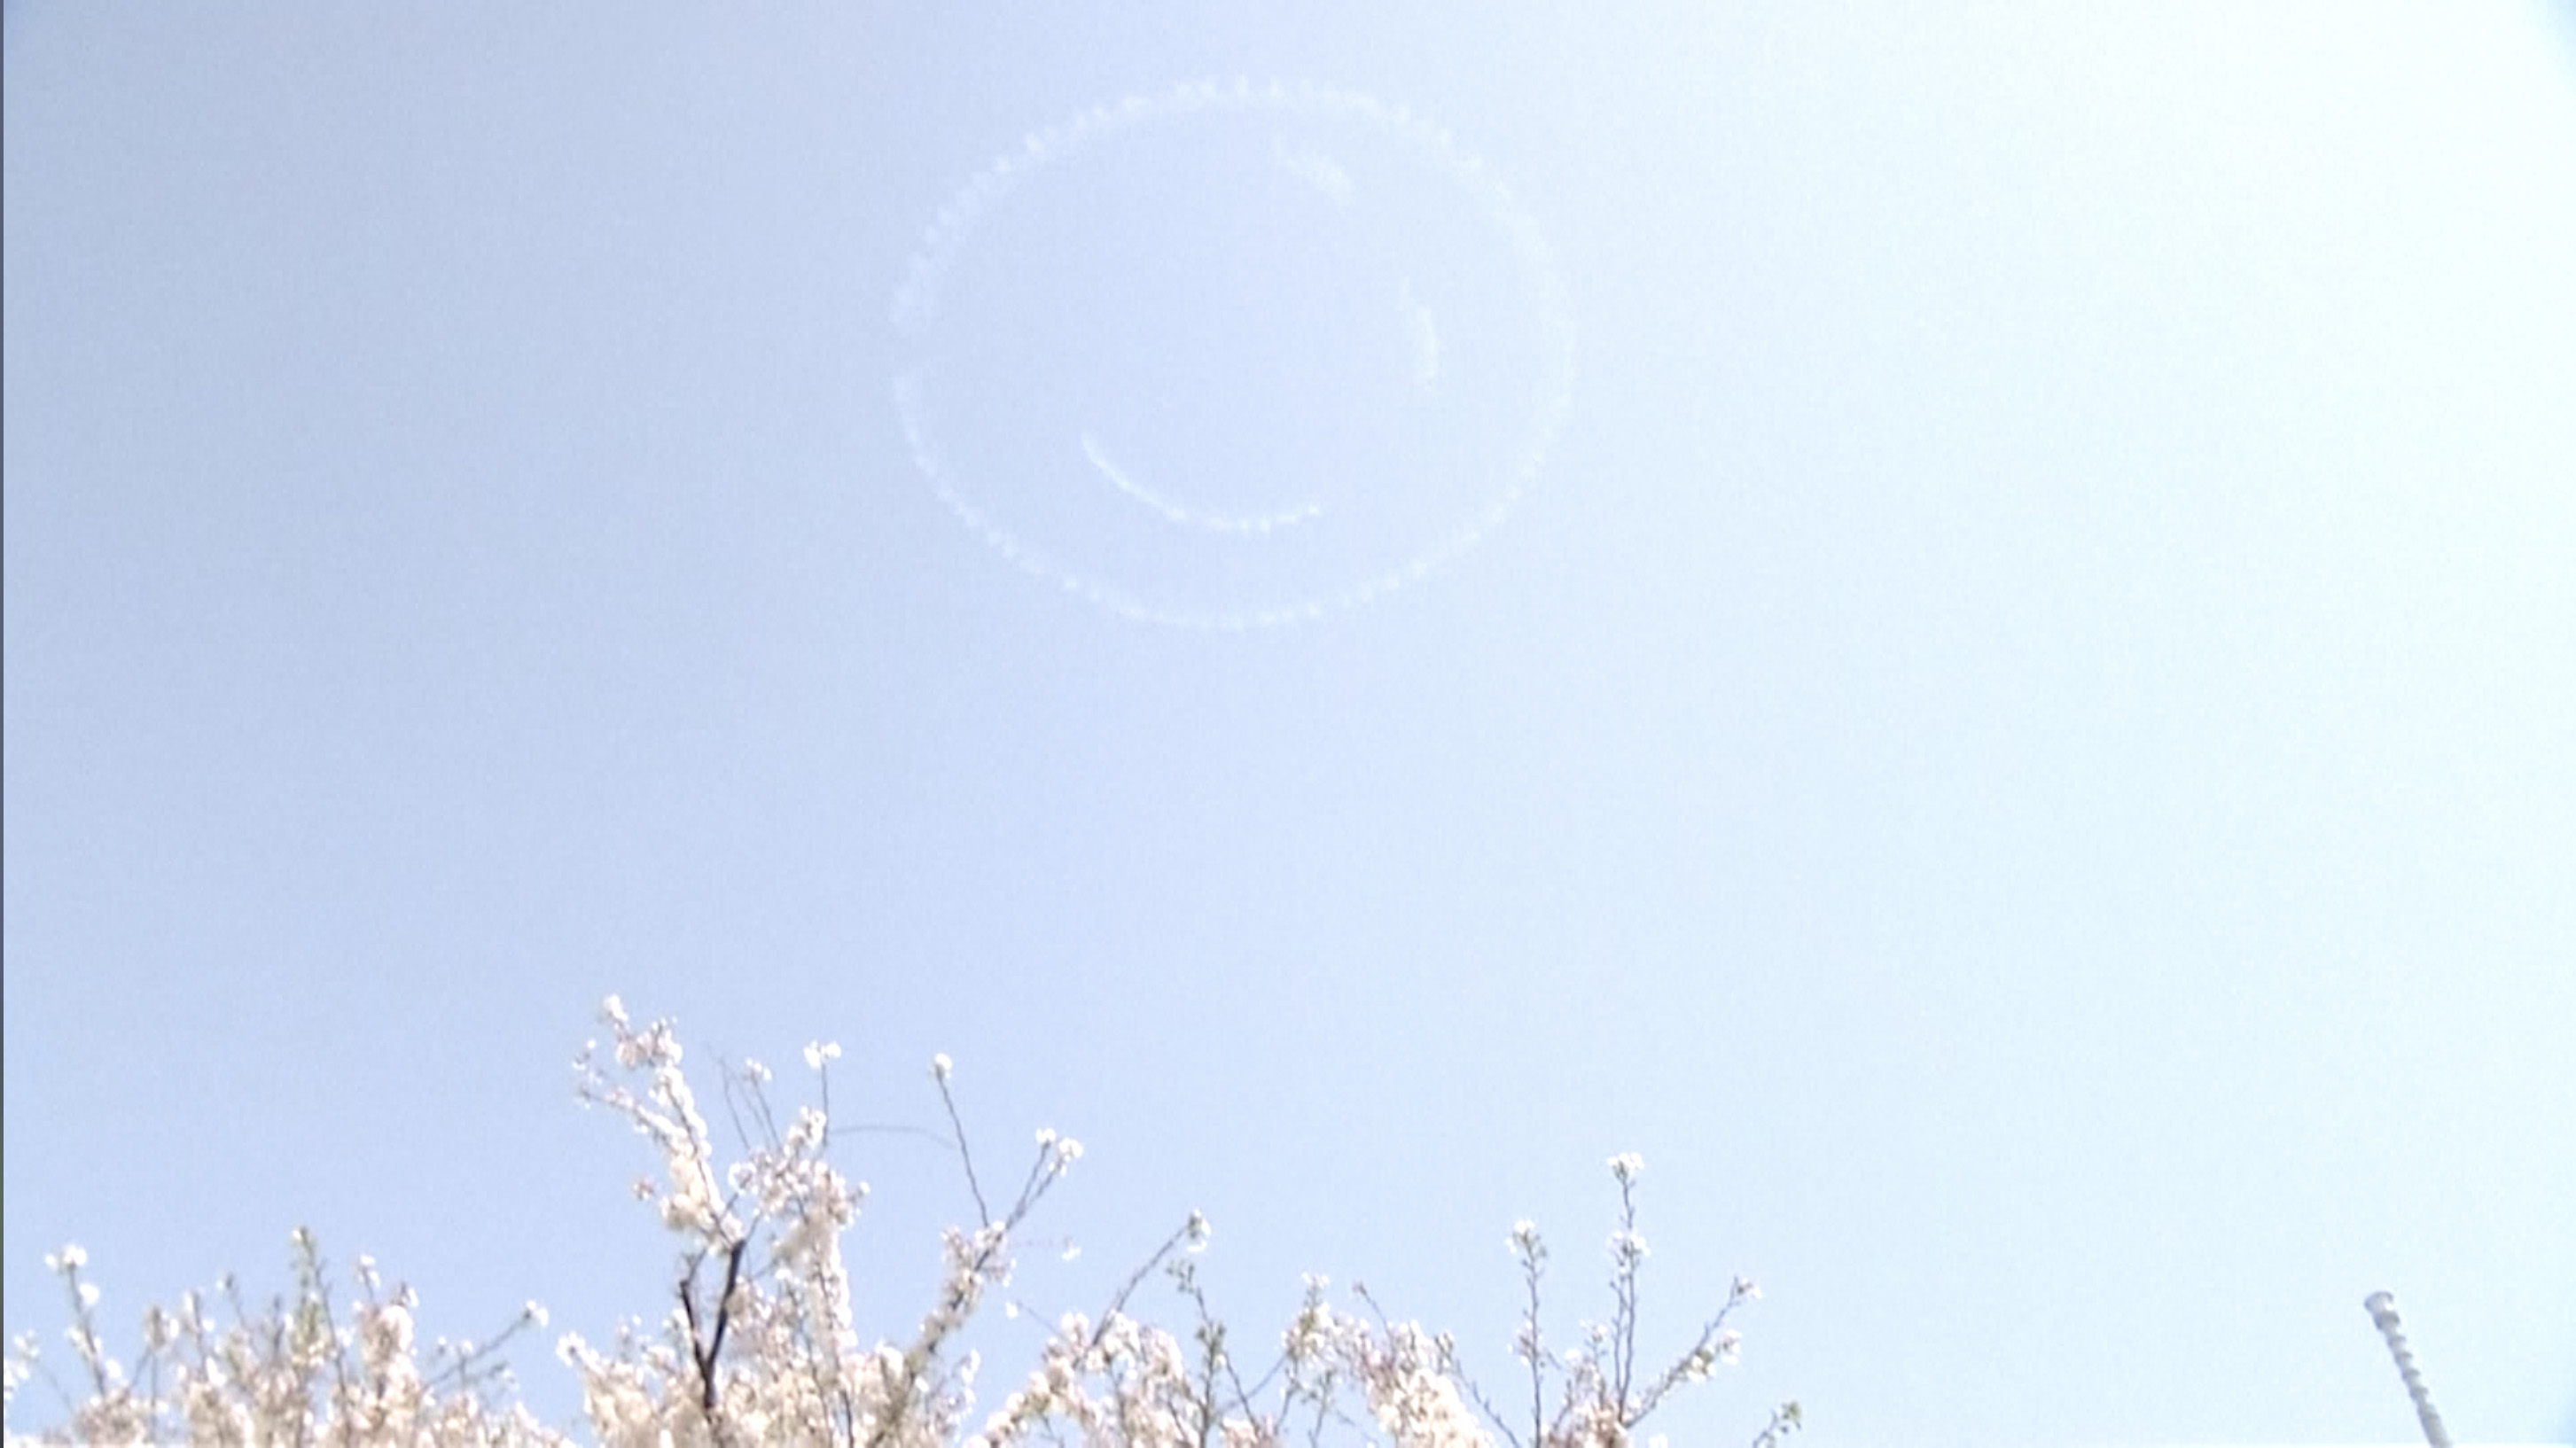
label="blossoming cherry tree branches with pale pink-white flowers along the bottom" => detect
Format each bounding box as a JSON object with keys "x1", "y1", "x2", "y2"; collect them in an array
[{"x1": 5, "y1": 997, "x2": 1798, "y2": 1448}]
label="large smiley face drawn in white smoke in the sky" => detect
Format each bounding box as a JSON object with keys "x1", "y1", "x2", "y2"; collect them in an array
[{"x1": 894, "y1": 82, "x2": 1574, "y2": 628}]
